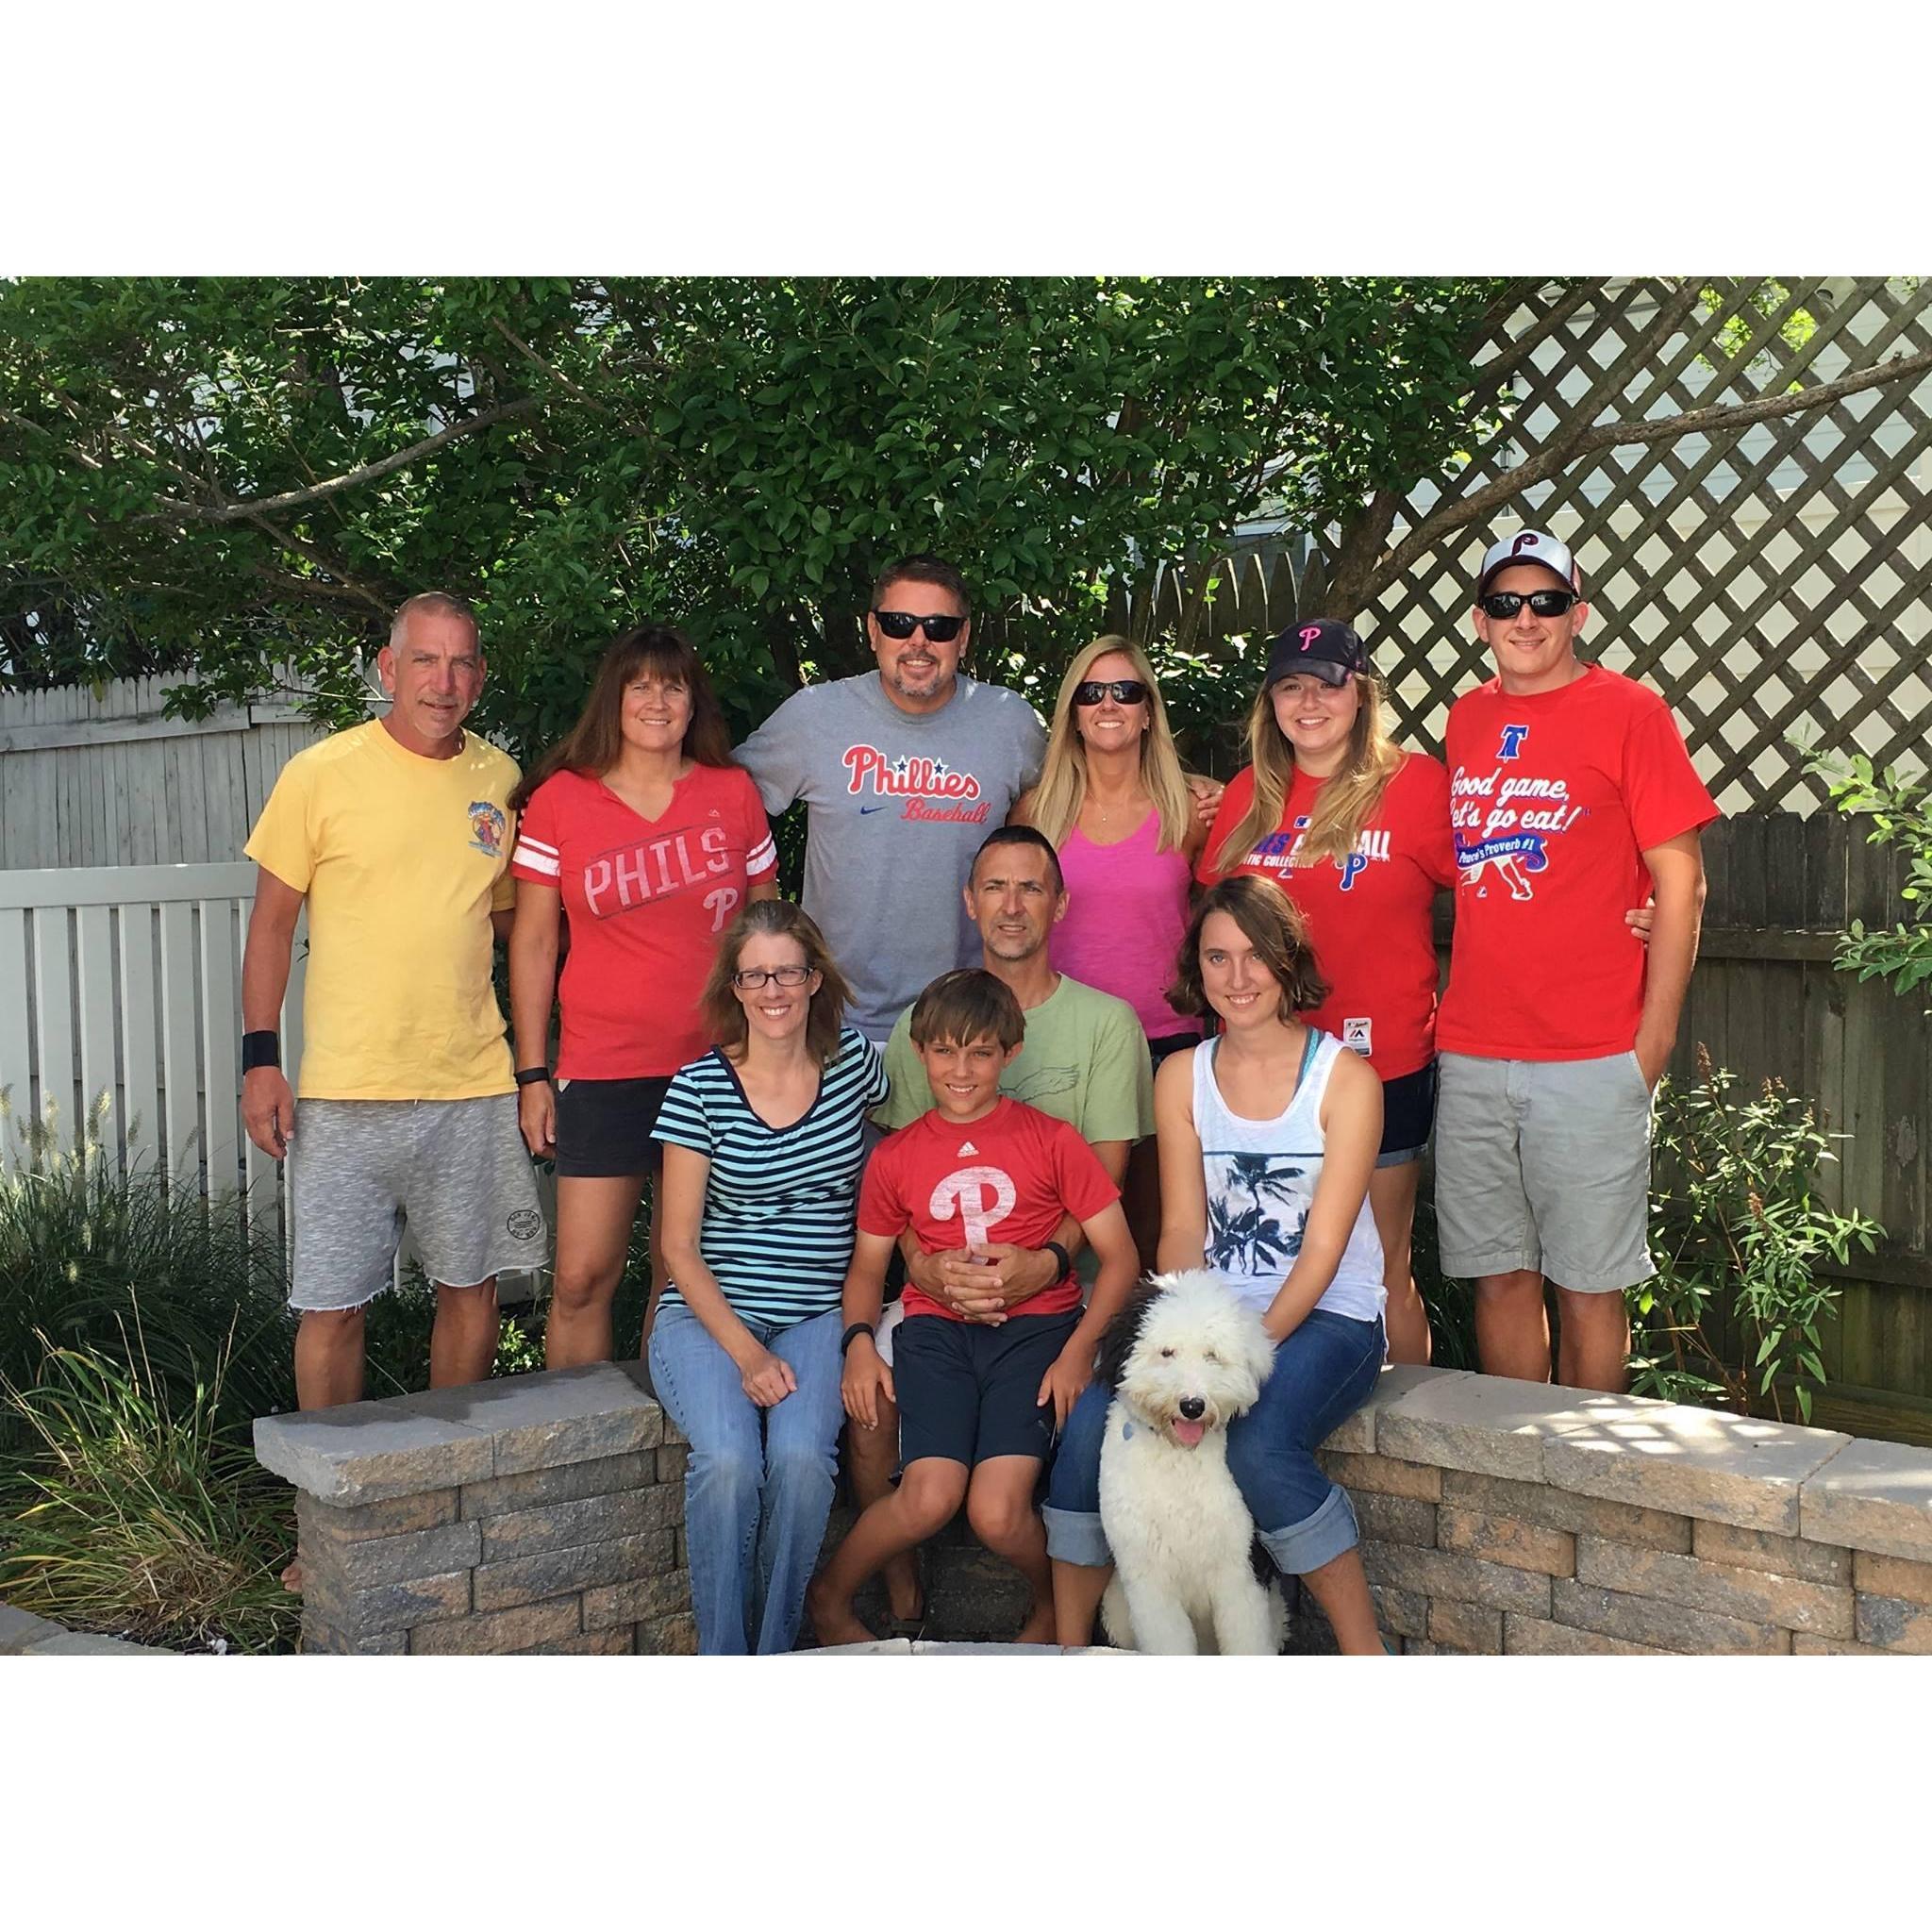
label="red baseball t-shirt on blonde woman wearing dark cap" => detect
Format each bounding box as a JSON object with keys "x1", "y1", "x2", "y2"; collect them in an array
[{"x1": 1194, "y1": 752, "x2": 1455, "y2": 1080}]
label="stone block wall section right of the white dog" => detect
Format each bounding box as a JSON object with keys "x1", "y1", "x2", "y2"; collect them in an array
[{"x1": 1296, "y1": 1368, "x2": 1932, "y2": 1656}]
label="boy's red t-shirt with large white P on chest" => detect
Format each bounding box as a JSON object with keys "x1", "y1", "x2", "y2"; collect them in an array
[{"x1": 858, "y1": 1097, "x2": 1121, "y2": 1322}]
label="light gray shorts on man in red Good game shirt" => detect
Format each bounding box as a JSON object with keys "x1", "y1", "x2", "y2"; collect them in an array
[{"x1": 1436, "y1": 1053, "x2": 1656, "y2": 1294}]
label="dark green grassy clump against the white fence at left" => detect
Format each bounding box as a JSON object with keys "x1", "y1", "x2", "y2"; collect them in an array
[{"x1": 0, "y1": 1099, "x2": 295, "y2": 1447}]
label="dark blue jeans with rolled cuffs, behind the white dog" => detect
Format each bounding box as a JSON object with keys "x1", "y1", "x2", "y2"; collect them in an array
[{"x1": 1041, "y1": 1307, "x2": 1385, "y2": 1576}]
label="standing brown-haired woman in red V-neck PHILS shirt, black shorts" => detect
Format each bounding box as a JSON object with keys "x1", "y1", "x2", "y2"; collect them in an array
[{"x1": 510, "y1": 625, "x2": 778, "y2": 1368}]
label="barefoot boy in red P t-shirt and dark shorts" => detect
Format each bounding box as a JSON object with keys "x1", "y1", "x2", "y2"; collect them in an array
[{"x1": 806, "y1": 968, "x2": 1138, "y2": 1644}]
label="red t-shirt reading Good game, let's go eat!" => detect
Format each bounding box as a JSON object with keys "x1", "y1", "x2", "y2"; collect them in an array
[{"x1": 1436, "y1": 665, "x2": 1718, "y2": 1060}]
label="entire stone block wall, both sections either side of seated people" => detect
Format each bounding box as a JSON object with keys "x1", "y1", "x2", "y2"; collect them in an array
[{"x1": 255, "y1": 1364, "x2": 1932, "y2": 1656}]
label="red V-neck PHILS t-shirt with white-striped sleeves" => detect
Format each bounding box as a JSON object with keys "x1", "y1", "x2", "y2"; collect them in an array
[{"x1": 510, "y1": 765, "x2": 778, "y2": 1080}]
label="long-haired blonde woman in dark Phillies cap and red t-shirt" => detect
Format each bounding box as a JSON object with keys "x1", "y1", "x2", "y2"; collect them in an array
[{"x1": 1196, "y1": 618, "x2": 1455, "y2": 1362}]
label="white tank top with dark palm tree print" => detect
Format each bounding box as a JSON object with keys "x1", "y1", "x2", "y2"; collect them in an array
[{"x1": 1194, "y1": 1028, "x2": 1387, "y2": 1322}]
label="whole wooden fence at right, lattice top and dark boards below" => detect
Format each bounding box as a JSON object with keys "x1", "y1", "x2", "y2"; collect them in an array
[{"x1": 1109, "y1": 278, "x2": 1932, "y2": 1441}]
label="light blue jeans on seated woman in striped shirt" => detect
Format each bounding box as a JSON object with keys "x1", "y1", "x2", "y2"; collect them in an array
[{"x1": 651, "y1": 1302, "x2": 844, "y2": 1657}]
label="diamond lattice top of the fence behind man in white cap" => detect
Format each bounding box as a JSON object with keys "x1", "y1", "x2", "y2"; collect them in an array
[{"x1": 1111, "y1": 278, "x2": 1932, "y2": 813}]
